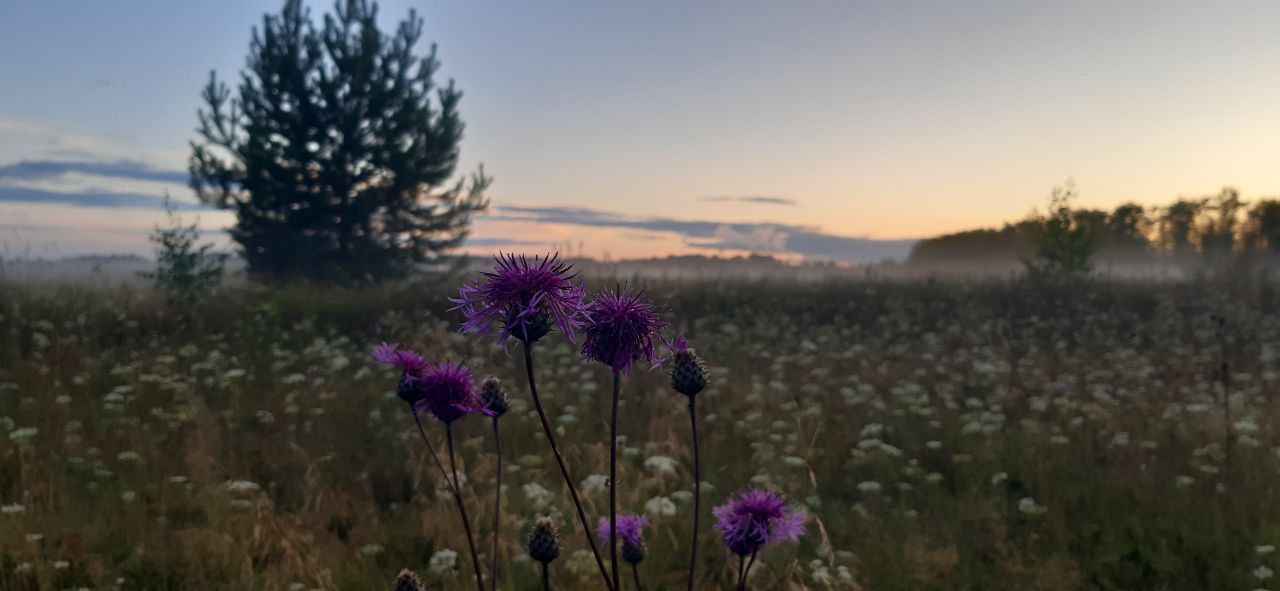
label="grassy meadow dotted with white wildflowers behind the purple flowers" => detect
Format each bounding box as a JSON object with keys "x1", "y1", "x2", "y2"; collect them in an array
[{"x1": 0, "y1": 276, "x2": 1280, "y2": 591}]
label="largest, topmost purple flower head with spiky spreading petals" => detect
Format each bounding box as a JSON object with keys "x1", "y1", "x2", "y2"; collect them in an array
[{"x1": 449, "y1": 255, "x2": 586, "y2": 343}]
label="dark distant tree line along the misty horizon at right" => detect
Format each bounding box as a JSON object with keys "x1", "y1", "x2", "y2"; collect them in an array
[{"x1": 909, "y1": 187, "x2": 1280, "y2": 265}]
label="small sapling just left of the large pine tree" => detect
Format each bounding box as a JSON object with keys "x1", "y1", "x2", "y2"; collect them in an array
[{"x1": 143, "y1": 194, "x2": 225, "y2": 301}]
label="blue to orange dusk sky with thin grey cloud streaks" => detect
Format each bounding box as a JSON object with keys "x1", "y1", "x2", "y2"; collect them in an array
[{"x1": 0, "y1": 0, "x2": 1280, "y2": 262}]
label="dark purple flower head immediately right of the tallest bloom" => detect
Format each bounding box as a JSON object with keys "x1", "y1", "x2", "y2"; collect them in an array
[{"x1": 582, "y1": 285, "x2": 667, "y2": 374}]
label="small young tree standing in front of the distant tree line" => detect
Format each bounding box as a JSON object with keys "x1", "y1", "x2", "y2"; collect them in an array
[{"x1": 1027, "y1": 180, "x2": 1106, "y2": 278}]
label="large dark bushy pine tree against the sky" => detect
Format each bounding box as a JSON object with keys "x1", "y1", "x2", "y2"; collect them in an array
[{"x1": 189, "y1": 0, "x2": 492, "y2": 281}]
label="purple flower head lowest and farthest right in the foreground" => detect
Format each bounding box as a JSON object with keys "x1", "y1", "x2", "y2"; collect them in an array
[{"x1": 712, "y1": 489, "x2": 809, "y2": 556}]
